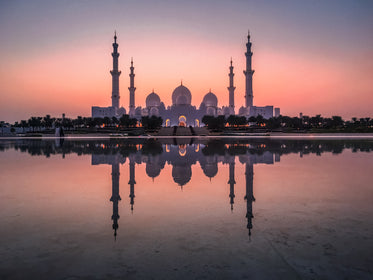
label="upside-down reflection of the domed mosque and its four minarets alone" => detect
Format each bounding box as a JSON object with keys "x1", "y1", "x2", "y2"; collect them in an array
[{"x1": 92, "y1": 140, "x2": 274, "y2": 237}]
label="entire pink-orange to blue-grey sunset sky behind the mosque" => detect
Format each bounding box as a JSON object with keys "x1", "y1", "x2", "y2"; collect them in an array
[{"x1": 0, "y1": 0, "x2": 373, "y2": 122}]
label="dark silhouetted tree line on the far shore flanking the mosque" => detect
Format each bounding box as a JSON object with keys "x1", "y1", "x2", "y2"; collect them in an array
[{"x1": 0, "y1": 115, "x2": 373, "y2": 135}]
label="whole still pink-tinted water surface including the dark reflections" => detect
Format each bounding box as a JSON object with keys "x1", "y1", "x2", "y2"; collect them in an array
[{"x1": 0, "y1": 138, "x2": 373, "y2": 279}]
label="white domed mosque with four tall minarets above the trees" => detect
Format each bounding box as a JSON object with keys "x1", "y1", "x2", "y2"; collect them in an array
[{"x1": 92, "y1": 30, "x2": 280, "y2": 124}]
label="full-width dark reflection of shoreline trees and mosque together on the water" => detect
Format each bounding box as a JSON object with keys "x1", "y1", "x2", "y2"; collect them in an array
[{"x1": 0, "y1": 138, "x2": 373, "y2": 238}]
